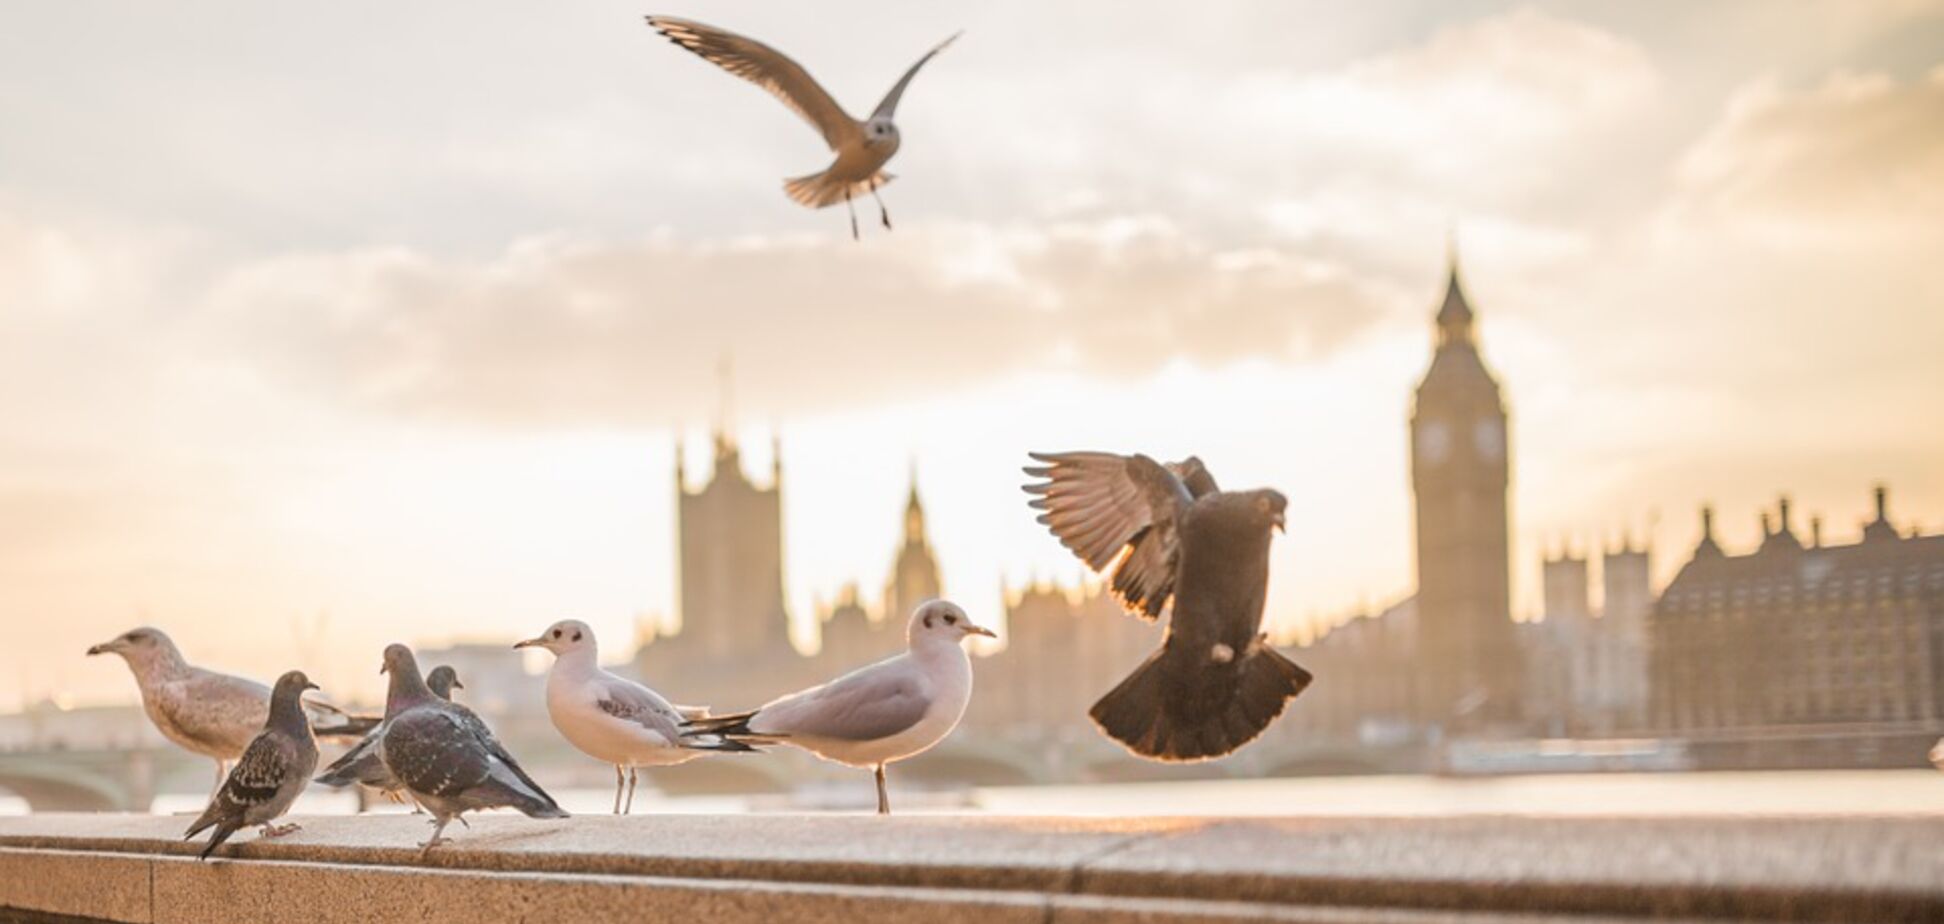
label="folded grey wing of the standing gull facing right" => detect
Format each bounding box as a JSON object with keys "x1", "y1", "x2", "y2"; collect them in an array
[{"x1": 752, "y1": 659, "x2": 931, "y2": 741}]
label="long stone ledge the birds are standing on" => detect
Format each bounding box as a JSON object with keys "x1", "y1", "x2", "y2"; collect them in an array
[{"x1": 0, "y1": 815, "x2": 1944, "y2": 924}]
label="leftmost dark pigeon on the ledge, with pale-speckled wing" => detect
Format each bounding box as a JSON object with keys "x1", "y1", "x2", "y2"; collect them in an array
[{"x1": 183, "y1": 671, "x2": 317, "y2": 860}]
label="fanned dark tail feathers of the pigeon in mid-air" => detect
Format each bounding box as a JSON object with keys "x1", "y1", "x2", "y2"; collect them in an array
[{"x1": 1089, "y1": 640, "x2": 1310, "y2": 763}]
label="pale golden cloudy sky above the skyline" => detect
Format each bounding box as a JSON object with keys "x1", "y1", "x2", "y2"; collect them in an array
[{"x1": 0, "y1": 0, "x2": 1944, "y2": 708}]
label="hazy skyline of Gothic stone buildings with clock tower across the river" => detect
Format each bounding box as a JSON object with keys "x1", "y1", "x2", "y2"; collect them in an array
[{"x1": 634, "y1": 257, "x2": 1944, "y2": 766}]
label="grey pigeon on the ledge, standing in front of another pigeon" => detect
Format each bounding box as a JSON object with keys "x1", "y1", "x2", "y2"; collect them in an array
[{"x1": 377, "y1": 644, "x2": 568, "y2": 856}]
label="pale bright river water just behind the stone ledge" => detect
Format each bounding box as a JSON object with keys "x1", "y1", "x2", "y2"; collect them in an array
[{"x1": 0, "y1": 770, "x2": 1944, "y2": 817}]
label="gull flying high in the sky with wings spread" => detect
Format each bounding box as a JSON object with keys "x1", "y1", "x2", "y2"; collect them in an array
[{"x1": 647, "y1": 16, "x2": 960, "y2": 239}]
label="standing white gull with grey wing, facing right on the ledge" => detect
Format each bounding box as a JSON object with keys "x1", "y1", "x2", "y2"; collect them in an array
[{"x1": 686, "y1": 599, "x2": 991, "y2": 815}]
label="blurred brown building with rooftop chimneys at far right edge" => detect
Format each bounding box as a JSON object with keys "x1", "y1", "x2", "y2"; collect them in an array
[{"x1": 1649, "y1": 488, "x2": 1944, "y2": 737}]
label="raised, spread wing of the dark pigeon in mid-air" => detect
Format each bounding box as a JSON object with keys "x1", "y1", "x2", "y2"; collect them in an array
[{"x1": 1026, "y1": 453, "x2": 1213, "y2": 619}]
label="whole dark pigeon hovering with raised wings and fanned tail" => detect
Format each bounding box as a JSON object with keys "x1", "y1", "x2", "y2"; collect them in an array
[{"x1": 1026, "y1": 453, "x2": 1310, "y2": 763}]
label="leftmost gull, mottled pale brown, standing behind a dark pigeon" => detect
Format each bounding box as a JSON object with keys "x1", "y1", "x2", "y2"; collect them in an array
[{"x1": 87, "y1": 626, "x2": 377, "y2": 796}]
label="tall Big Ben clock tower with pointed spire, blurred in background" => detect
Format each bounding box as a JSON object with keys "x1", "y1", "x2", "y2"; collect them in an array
[{"x1": 1411, "y1": 255, "x2": 1524, "y2": 731}]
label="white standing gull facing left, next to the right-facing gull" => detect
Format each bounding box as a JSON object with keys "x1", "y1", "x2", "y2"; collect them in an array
[{"x1": 513, "y1": 619, "x2": 754, "y2": 815}]
